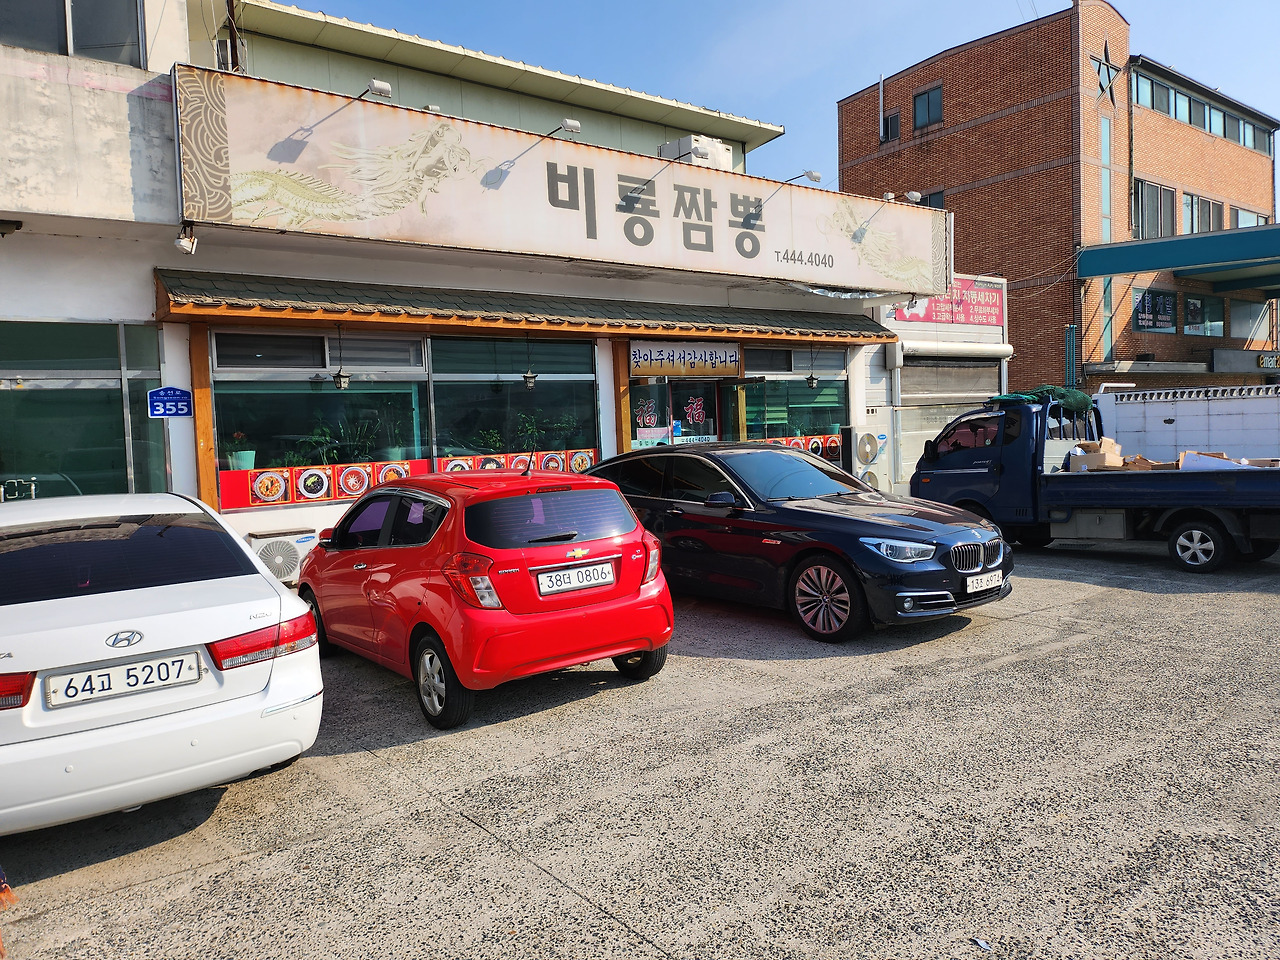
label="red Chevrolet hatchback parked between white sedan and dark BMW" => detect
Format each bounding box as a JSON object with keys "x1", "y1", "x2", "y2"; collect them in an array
[{"x1": 298, "y1": 470, "x2": 672, "y2": 730}]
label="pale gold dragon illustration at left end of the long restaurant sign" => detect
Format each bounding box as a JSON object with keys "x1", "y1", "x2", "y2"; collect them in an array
[{"x1": 230, "y1": 123, "x2": 480, "y2": 228}]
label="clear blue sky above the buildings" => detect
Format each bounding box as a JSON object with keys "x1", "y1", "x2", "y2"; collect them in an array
[{"x1": 293, "y1": 0, "x2": 1280, "y2": 192}]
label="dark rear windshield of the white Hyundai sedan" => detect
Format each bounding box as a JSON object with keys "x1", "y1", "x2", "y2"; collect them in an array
[{"x1": 0, "y1": 513, "x2": 257, "y2": 605}]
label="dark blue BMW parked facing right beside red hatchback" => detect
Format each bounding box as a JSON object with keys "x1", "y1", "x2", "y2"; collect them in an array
[{"x1": 590, "y1": 443, "x2": 1014, "y2": 643}]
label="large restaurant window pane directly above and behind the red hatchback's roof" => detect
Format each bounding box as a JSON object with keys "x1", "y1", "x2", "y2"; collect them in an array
[{"x1": 435, "y1": 379, "x2": 599, "y2": 457}]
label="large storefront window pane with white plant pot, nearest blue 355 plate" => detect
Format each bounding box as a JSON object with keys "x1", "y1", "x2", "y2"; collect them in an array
[{"x1": 214, "y1": 379, "x2": 429, "y2": 470}]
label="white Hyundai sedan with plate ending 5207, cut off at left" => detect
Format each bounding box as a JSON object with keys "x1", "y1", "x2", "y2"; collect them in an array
[{"x1": 0, "y1": 494, "x2": 323, "y2": 836}]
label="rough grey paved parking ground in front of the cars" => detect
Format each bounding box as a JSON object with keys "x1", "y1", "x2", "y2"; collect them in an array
[{"x1": 0, "y1": 545, "x2": 1280, "y2": 960}]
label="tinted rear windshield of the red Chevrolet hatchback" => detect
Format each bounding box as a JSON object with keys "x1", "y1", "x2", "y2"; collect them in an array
[{"x1": 466, "y1": 490, "x2": 636, "y2": 549}]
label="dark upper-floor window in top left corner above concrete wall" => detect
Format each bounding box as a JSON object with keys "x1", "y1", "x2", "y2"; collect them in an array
[{"x1": 0, "y1": 0, "x2": 142, "y2": 67}]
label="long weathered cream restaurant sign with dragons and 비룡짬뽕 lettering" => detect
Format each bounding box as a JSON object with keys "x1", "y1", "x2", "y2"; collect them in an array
[{"x1": 174, "y1": 65, "x2": 950, "y2": 296}]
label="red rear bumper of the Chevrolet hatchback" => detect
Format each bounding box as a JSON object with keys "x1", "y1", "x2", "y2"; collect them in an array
[{"x1": 448, "y1": 575, "x2": 675, "y2": 690}]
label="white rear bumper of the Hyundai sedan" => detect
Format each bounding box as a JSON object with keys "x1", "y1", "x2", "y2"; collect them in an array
[{"x1": 0, "y1": 648, "x2": 324, "y2": 836}]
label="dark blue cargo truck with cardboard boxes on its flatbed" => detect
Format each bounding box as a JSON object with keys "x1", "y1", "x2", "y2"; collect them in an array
[{"x1": 911, "y1": 399, "x2": 1280, "y2": 573}]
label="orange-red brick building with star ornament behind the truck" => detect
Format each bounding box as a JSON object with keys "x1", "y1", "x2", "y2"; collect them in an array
[{"x1": 837, "y1": 0, "x2": 1280, "y2": 389}]
